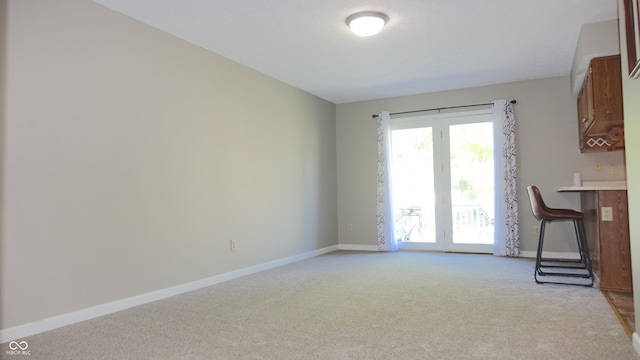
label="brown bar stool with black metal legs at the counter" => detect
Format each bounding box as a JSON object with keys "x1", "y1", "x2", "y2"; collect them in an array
[{"x1": 527, "y1": 186, "x2": 593, "y2": 286}]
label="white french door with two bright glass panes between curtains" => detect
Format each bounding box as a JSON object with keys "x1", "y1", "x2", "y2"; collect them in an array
[{"x1": 391, "y1": 110, "x2": 495, "y2": 252}]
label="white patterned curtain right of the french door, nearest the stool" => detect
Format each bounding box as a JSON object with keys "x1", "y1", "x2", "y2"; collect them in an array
[{"x1": 493, "y1": 100, "x2": 520, "y2": 256}]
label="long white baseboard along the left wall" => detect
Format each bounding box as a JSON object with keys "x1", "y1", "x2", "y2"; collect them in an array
[{"x1": 0, "y1": 245, "x2": 340, "y2": 343}]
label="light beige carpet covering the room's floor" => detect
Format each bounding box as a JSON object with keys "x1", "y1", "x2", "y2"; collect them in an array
[{"x1": 2, "y1": 251, "x2": 640, "y2": 360}]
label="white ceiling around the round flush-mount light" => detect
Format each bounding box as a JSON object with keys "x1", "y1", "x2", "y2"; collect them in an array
[{"x1": 94, "y1": 0, "x2": 617, "y2": 104}]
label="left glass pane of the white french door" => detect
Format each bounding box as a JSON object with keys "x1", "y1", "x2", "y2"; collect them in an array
[{"x1": 391, "y1": 127, "x2": 436, "y2": 243}]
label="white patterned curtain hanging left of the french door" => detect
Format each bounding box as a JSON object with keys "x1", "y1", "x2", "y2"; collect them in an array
[{"x1": 377, "y1": 112, "x2": 398, "y2": 251}]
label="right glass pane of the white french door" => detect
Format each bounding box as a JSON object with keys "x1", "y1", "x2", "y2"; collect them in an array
[{"x1": 449, "y1": 122, "x2": 494, "y2": 244}]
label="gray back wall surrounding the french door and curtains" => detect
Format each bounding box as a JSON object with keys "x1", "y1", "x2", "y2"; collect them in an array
[{"x1": 336, "y1": 75, "x2": 625, "y2": 252}]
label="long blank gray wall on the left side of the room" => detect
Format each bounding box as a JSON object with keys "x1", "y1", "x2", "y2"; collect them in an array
[{"x1": 1, "y1": 0, "x2": 338, "y2": 328}]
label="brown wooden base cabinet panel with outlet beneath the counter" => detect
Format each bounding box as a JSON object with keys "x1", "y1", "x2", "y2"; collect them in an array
[{"x1": 581, "y1": 190, "x2": 632, "y2": 291}]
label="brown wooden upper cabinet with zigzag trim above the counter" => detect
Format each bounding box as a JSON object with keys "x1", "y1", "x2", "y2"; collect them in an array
[{"x1": 578, "y1": 55, "x2": 624, "y2": 152}]
